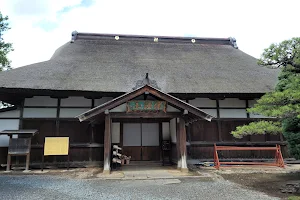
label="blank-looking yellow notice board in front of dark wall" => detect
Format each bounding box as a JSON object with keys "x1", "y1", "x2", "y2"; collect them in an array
[{"x1": 44, "y1": 137, "x2": 69, "y2": 156}]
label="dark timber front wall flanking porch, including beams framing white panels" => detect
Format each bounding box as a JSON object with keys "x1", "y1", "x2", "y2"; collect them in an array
[{"x1": 0, "y1": 95, "x2": 288, "y2": 164}]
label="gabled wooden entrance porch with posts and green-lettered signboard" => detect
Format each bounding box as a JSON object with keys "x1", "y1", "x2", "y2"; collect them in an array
[{"x1": 77, "y1": 83, "x2": 213, "y2": 173}]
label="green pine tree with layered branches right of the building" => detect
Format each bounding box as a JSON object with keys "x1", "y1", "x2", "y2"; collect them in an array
[{"x1": 231, "y1": 38, "x2": 300, "y2": 158}]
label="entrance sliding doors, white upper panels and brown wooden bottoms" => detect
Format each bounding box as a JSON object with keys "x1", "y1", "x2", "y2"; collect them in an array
[{"x1": 122, "y1": 123, "x2": 161, "y2": 161}]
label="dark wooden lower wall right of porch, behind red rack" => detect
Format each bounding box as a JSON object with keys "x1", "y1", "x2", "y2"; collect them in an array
[{"x1": 188, "y1": 119, "x2": 288, "y2": 159}]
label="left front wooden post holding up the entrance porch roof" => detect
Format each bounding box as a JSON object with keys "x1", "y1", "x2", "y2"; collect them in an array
[{"x1": 103, "y1": 114, "x2": 111, "y2": 174}]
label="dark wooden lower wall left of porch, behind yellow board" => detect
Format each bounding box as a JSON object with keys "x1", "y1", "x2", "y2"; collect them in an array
[{"x1": 23, "y1": 119, "x2": 104, "y2": 163}]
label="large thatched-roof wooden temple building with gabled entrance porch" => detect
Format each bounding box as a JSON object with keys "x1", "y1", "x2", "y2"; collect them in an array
[{"x1": 0, "y1": 32, "x2": 286, "y2": 172}]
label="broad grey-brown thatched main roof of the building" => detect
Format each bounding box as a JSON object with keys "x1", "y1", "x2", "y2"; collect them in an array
[{"x1": 0, "y1": 33, "x2": 277, "y2": 93}]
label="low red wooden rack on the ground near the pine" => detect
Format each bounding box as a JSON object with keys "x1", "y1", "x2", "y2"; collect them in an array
[{"x1": 214, "y1": 144, "x2": 284, "y2": 169}]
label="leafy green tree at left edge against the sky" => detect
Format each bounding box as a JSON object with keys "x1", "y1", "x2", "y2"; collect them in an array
[{"x1": 0, "y1": 12, "x2": 13, "y2": 71}]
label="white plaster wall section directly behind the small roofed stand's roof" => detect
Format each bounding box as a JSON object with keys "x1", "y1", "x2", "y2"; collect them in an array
[{"x1": 0, "y1": 119, "x2": 19, "y2": 147}]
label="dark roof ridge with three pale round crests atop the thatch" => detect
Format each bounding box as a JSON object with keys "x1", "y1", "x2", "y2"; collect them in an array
[{"x1": 71, "y1": 31, "x2": 238, "y2": 49}]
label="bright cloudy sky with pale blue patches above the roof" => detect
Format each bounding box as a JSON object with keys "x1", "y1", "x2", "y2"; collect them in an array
[{"x1": 0, "y1": 0, "x2": 300, "y2": 68}]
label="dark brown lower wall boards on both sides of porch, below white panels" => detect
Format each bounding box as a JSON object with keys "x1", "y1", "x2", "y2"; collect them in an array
[{"x1": 0, "y1": 119, "x2": 288, "y2": 164}]
